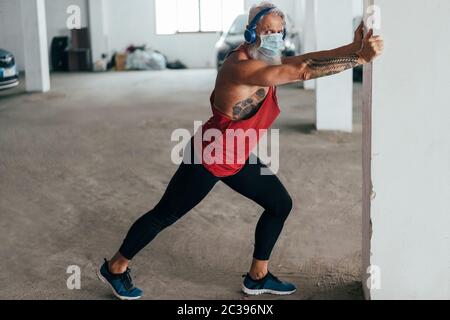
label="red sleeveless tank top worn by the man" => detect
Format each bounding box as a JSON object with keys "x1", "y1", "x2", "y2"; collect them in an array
[{"x1": 194, "y1": 45, "x2": 280, "y2": 178}]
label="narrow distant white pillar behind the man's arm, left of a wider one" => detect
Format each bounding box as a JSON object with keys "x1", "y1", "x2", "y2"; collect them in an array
[{"x1": 302, "y1": 0, "x2": 317, "y2": 90}]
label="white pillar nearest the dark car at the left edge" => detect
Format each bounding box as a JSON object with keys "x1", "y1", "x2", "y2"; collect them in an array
[{"x1": 21, "y1": 0, "x2": 50, "y2": 92}]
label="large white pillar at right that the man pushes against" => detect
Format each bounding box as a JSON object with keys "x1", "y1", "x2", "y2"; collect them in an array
[{"x1": 363, "y1": 0, "x2": 450, "y2": 299}]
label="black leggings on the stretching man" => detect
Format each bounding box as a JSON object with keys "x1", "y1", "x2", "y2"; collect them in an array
[{"x1": 119, "y1": 159, "x2": 292, "y2": 261}]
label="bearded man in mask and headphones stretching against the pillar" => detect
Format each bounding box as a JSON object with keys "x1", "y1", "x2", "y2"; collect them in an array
[{"x1": 98, "y1": 3, "x2": 383, "y2": 300}]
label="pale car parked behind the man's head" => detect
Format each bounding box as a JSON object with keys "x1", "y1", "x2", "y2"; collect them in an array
[{"x1": 216, "y1": 14, "x2": 300, "y2": 69}]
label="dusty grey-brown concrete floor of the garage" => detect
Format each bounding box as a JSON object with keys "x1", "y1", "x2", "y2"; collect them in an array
[{"x1": 0, "y1": 70, "x2": 362, "y2": 300}]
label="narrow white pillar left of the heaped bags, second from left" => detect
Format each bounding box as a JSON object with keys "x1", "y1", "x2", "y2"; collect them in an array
[{"x1": 88, "y1": 0, "x2": 109, "y2": 65}]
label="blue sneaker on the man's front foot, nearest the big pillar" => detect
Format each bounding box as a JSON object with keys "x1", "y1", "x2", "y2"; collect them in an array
[{"x1": 242, "y1": 272, "x2": 297, "y2": 296}]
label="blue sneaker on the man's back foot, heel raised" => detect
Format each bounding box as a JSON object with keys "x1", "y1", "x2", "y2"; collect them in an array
[{"x1": 97, "y1": 259, "x2": 142, "y2": 300}]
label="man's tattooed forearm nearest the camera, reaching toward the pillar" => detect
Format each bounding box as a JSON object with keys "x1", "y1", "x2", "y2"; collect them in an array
[{"x1": 305, "y1": 54, "x2": 359, "y2": 79}]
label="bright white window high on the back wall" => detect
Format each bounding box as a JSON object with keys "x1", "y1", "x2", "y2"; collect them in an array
[{"x1": 155, "y1": 0, "x2": 244, "y2": 34}]
